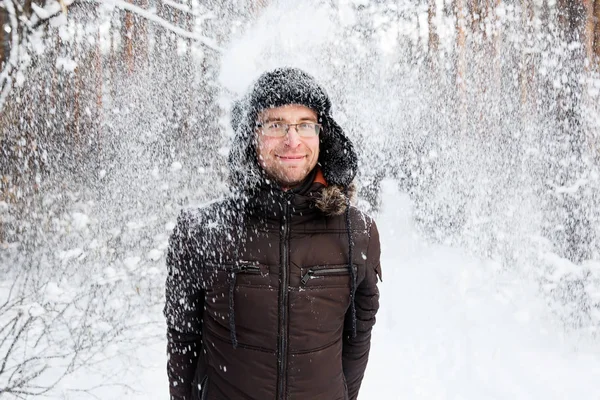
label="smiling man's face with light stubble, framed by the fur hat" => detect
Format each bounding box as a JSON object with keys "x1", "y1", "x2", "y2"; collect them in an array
[{"x1": 256, "y1": 104, "x2": 319, "y2": 189}]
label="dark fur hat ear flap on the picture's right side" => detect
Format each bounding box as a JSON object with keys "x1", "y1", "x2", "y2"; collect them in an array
[{"x1": 319, "y1": 117, "x2": 358, "y2": 188}]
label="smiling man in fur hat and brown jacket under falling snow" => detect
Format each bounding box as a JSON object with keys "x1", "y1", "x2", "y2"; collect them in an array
[{"x1": 165, "y1": 68, "x2": 381, "y2": 400}]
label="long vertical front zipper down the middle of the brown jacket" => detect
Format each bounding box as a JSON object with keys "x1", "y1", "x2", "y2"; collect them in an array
[{"x1": 277, "y1": 196, "x2": 290, "y2": 400}]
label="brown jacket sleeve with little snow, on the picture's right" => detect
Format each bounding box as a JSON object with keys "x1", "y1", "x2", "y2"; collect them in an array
[{"x1": 342, "y1": 221, "x2": 381, "y2": 400}]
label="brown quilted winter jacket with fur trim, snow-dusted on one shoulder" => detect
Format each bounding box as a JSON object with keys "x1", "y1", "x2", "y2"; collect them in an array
[{"x1": 165, "y1": 170, "x2": 381, "y2": 400}]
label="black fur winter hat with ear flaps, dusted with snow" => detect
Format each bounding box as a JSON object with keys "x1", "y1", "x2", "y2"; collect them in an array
[{"x1": 229, "y1": 68, "x2": 358, "y2": 189}]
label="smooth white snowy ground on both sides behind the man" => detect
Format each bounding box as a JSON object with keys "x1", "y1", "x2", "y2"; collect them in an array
[{"x1": 51, "y1": 182, "x2": 600, "y2": 400}]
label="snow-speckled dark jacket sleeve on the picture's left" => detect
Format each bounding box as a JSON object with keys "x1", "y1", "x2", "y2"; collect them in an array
[{"x1": 164, "y1": 213, "x2": 204, "y2": 400}]
